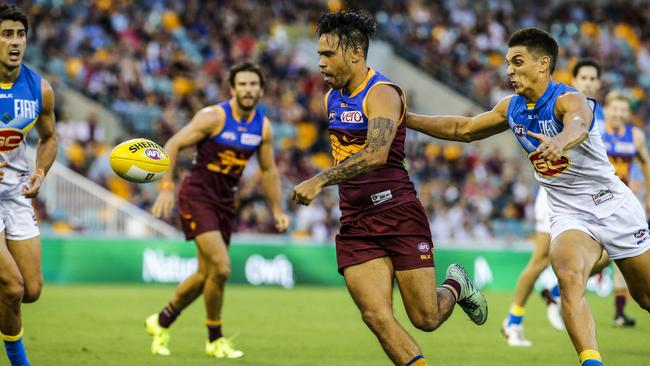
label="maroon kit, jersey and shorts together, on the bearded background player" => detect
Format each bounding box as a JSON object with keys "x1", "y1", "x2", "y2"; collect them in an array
[{"x1": 178, "y1": 101, "x2": 265, "y2": 243}]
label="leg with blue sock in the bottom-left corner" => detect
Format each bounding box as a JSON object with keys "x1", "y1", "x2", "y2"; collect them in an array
[{"x1": 0, "y1": 230, "x2": 29, "y2": 365}]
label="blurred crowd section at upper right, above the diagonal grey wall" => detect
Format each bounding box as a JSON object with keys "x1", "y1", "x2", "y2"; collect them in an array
[{"x1": 368, "y1": 0, "x2": 650, "y2": 128}]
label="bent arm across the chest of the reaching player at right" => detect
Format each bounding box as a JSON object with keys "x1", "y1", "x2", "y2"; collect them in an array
[{"x1": 528, "y1": 93, "x2": 594, "y2": 161}]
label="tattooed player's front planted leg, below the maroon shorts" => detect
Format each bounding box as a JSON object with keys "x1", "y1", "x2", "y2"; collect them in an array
[{"x1": 343, "y1": 257, "x2": 426, "y2": 365}]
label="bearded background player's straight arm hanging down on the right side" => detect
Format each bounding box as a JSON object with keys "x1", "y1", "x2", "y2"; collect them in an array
[{"x1": 257, "y1": 118, "x2": 289, "y2": 232}]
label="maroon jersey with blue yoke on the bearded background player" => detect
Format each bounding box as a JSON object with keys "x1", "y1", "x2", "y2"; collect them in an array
[{"x1": 181, "y1": 101, "x2": 265, "y2": 205}]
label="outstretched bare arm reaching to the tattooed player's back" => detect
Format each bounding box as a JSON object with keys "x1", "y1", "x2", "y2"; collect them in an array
[{"x1": 406, "y1": 97, "x2": 511, "y2": 142}]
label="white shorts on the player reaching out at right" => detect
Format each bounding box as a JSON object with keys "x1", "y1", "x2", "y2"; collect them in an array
[{"x1": 551, "y1": 191, "x2": 650, "y2": 259}]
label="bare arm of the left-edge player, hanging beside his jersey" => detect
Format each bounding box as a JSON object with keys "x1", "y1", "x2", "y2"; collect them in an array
[{"x1": 23, "y1": 79, "x2": 57, "y2": 198}]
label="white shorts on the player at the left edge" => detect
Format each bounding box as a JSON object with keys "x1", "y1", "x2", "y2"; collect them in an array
[{"x1": 0, "y1": 196, "x2": 41, "y2": 240}]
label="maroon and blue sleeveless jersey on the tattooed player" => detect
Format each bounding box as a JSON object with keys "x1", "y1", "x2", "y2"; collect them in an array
[{"x1": 325, "y1": 69, "x2": 417, "y2": 223}]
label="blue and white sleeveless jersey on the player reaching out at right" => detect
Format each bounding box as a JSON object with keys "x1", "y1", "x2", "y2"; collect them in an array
[{"x1": 506, "y1": 81, "x2": 629, "y2": 219}]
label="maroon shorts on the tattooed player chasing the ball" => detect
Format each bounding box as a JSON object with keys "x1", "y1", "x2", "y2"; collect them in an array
[{"x1": 336, "y1": 201, "x2": 433, "y2": 274}]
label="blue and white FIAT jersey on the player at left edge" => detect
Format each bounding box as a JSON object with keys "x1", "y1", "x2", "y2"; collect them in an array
[{"x1": 0, "y1": 65, "x2": 43, "y2": 197}]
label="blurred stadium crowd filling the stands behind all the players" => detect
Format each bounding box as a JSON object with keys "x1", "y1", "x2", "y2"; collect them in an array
[{"x1": 29, "y1": 0, "x2": 650, "y2": 241}]
